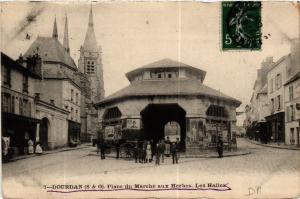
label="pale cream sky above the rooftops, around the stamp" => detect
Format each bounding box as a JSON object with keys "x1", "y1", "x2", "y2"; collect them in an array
[{"x1": 0, "y1": 1, "x2": 300, "y2": 116}]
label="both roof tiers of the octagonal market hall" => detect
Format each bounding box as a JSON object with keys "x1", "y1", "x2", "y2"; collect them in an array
[{"x1": 97, "y1": 59, "x2": 241, "y2": 106}]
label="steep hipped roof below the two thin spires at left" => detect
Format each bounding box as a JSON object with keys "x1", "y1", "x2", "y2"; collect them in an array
[{"x1": 24, "y1": 37, "x2": 77, "y2": 69}]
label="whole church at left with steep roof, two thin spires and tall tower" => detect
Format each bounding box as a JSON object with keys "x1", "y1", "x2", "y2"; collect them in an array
[{"x1": 18, "y1": 9, "x2": 104, "y2": 145}]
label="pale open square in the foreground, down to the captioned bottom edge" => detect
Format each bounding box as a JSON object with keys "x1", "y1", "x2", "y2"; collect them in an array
[{"x1": 2, "y1": 138, "x2": 300, "y2": 198}]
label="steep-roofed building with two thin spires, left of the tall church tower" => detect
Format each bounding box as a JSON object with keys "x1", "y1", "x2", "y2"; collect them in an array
[{"x1": 18, "y1": 15, "x2": 81, "y2": 149}]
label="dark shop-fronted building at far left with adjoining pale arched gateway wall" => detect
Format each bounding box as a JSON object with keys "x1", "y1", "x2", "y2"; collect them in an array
[{"x1": 1, "y1": 53, "x2": 69, "y2": 155}]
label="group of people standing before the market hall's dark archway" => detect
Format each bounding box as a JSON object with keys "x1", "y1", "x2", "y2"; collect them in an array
[{"x1": 134, "y1": 137, "x2": 179, "y2": 165}]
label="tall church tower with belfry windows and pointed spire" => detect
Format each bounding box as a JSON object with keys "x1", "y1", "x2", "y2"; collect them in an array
[{"x1": 78, "y1": 7, "x2": 104, "y2": 103}]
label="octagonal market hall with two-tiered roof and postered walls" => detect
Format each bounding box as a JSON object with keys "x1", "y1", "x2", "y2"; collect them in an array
[{"x1": 97, "y1": 59, "x2": 240, "y2": 153}]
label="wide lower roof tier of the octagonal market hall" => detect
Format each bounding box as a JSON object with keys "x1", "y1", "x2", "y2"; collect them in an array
[{"x1": 98, "y1": 79, "x2": 241, "y2": 105}]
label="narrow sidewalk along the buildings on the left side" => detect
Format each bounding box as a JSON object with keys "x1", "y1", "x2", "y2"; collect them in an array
[{"x1": 7, "y1": 143, "x2": 92, "y2": 162}]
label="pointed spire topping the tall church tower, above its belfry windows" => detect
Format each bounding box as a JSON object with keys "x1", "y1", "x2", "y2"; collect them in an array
[{"x1": 83, "y1": 6, "x2": 99, "y2": 52}]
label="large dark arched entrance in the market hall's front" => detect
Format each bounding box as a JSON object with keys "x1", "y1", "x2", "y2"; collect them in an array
[{"x1": 141, "y1": 104, "x2": 186, "y2": 150}]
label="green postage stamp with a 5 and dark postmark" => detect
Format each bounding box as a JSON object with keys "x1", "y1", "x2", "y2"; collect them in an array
[{"x1": 222, "y1": 1, "x2": 262, "y2": 50}]
